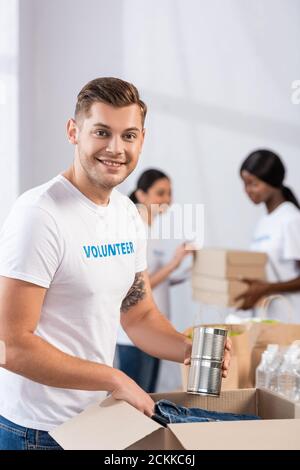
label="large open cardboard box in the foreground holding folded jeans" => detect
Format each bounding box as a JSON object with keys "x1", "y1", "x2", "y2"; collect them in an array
[{"x1": 50, "y1": 389, "x2": 300, "y2": 450}]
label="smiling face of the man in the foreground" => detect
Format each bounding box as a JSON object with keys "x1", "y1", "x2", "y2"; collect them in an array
[{"x1": 68, "y1": 102, "x2": 144, "y2": 190}]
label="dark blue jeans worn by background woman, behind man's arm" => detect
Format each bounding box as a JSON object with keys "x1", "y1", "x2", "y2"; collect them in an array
[{"x1": 117, "y1": 344, "x2": 159, "y2": 393}]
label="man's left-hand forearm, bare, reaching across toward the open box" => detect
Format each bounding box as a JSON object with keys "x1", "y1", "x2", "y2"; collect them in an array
[{"x1": 3, "y1": 334, "x2": 121, "y2": 391}]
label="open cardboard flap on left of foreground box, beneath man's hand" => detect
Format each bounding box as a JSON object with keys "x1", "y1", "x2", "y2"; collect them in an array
[{"x1": 50, "y1": 397, "x2": 162, "y2": 450}]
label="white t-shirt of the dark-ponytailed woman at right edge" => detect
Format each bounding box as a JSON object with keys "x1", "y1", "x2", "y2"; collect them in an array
[{"x1": 251, "y1": 202, "x2": 300, "y2": 323}]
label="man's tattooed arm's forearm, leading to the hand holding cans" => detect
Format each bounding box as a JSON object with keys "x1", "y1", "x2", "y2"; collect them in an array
[{"x1": 126, "y1": 309, "x2": 190, "y2": 363}]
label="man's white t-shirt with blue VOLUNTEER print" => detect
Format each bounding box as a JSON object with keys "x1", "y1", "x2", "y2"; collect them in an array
[{"x1": 0, "y1": 175, "x2": 146, "y2": 431}]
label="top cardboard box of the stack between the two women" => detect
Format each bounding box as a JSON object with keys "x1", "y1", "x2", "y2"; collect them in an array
[{"x1": 193, "y1": 248, "x2": 267, "y2": 280}]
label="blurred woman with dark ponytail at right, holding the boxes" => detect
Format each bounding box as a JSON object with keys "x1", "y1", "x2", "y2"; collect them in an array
[{"x1": 238, "y1": 149, "x2": 300, "y2": 322}]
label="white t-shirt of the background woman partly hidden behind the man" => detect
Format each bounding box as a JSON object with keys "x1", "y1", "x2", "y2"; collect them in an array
[{"x1": 117, "y1": 220, "x2": 170, "y2": 346}]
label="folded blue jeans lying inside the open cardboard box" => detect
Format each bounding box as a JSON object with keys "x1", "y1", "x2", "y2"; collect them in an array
[{"x1": 155, "y1": 400, "x2": 260, "y2": 423}]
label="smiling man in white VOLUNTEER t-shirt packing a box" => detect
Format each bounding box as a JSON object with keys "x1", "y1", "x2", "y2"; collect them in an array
[{"x1": 0, "y1": 78, "x2": 230, "y2": 449}]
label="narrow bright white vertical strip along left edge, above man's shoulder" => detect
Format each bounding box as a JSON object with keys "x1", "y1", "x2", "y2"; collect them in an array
[{"x1": 0, "y1": 0, "x2": 18, "y2": 225}]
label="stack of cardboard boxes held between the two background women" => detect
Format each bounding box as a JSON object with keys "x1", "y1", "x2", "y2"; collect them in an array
[{"x1": 192, "y1": 248, "x2": 267, "y2": 308}]
